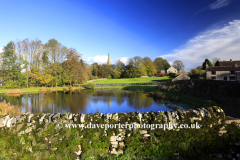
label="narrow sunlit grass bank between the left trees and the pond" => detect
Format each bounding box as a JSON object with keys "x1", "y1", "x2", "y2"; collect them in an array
[{"x1": 0, "y1": 87, "x2": 83, "y2": 93}]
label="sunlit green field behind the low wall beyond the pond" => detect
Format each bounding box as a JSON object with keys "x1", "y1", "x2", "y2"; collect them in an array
[{"x1": 92, "y1": 76, "x2": 173, "y2": 84}]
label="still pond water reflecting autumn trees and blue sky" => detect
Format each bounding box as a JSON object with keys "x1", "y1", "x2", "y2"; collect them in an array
[{"x1": 0, "y1": 90, "x2": 190, "y2": 114}]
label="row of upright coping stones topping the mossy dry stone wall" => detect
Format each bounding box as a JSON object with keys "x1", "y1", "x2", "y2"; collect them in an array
[{"x1": 0, "y1": 106, "x2": 225, "y2": 130}]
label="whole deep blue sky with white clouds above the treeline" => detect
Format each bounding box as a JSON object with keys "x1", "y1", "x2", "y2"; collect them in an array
[{"x1": 0, "y1": 0, "x2": 240, "y2": 71}]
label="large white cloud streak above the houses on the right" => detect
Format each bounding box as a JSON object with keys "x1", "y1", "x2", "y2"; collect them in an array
[{"x1": 161, "y1": 20, "x2": 240, "y2": 71}]
